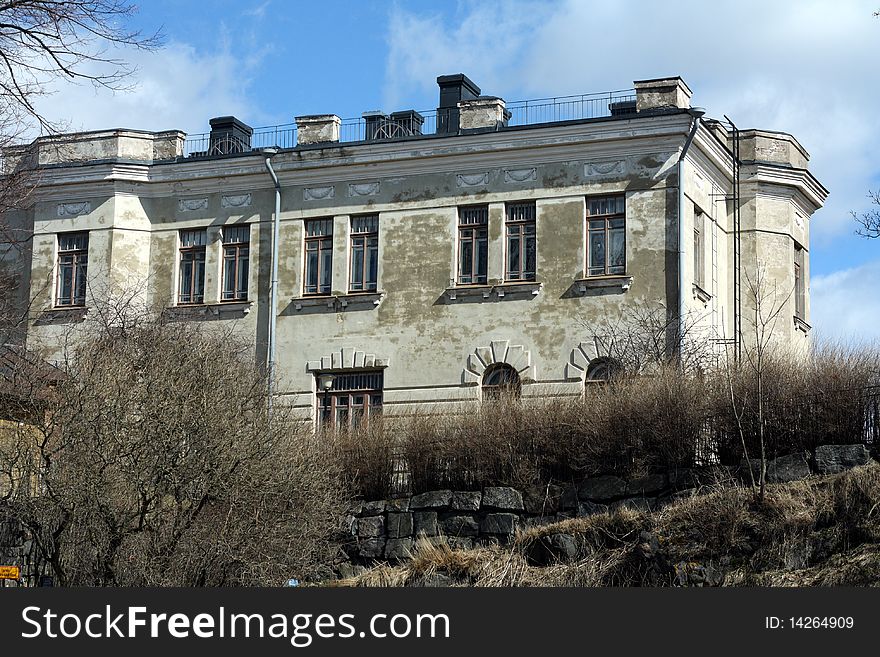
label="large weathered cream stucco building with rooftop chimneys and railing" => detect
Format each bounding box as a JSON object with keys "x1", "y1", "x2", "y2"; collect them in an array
[{"x1": 1, "y1": 75, "x2": 827, "y2": 422}]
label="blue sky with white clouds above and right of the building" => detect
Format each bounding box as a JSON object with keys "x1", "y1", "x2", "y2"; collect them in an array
[{"x1": 36, "y1": 0, "x2": 880, "y2": 339}]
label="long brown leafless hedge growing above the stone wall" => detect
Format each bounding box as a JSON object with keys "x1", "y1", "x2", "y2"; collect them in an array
[{"x1": 335, "y1": 348, "x2": 880, "y2": 499}]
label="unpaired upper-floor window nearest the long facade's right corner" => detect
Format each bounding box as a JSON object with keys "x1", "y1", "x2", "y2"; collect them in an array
[{"x1": 587, "y1": 195, "x2": 626, "y2": 276}]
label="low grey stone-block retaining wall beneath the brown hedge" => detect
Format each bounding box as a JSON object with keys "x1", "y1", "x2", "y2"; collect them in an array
[{"x1": 342, "y1": 445, "x2": 871, "y2": 576}]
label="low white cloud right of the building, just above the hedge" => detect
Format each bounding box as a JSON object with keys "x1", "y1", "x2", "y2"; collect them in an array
[{"x1": 810, "y1": 260, "x2": 880, "y2": 341}]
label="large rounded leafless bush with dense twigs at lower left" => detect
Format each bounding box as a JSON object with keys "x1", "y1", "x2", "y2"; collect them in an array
[{"x1": 0, "y1": 304, "x2": 345, "y2": 586}]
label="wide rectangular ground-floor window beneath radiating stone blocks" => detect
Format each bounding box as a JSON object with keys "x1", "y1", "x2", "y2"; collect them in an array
[{"x1": 318, "y1": 370, "x2": 383, "y2": 429}]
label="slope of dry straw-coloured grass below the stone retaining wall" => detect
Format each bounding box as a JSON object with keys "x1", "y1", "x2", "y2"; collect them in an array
[{"x1": 333, "y1": 463, "x2": 880, "y2": 586}]
